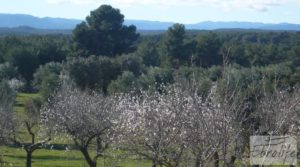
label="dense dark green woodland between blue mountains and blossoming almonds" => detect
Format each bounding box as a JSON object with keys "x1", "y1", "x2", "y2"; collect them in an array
[{"x1": 0, "y1": 22, "x2": 300, "y2": 94}]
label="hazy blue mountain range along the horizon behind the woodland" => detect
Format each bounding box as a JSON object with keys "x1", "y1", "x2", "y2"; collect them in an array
[{"x1": 0, "y1": 14, "x2": 300, "y2": 32}]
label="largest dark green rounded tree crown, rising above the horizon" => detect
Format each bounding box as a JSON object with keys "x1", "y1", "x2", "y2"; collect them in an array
[{"x1": 73, "y1": 5, "x2": 139, "y2": 56}]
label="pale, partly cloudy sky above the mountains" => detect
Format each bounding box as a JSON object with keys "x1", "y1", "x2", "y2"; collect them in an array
[{"x1": 0, "y1": 0, "x2": 300, "y2": 24}]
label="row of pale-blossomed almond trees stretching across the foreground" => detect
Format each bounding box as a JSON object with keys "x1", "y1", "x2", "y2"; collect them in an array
[{"x1": 0, "y1": 71, "x2": 300, "y2": 167}]
